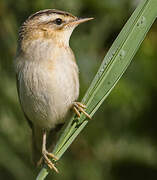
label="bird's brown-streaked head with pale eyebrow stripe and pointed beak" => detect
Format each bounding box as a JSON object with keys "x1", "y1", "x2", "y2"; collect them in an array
[{"x1": 19, "y1": 9, "x2": 93, "y2": 48}]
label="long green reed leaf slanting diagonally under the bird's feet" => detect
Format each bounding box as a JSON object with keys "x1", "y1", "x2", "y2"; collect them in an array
[{"x1": 37, "y1": 0, "x2": 157, "y2": 180}]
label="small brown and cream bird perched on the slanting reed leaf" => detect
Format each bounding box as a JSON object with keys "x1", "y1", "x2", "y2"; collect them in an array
[{"x1": 14, "y1": 9, "x2": 93, "y2": 172}]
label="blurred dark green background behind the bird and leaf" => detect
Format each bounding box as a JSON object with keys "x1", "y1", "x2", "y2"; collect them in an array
[{"x1": 0, "y1": 0, "x2": 157, "y2": 180}]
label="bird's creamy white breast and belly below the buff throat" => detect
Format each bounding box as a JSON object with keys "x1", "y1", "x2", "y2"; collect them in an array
[{"x1": 17, "y1": 39, "x2": 79, "y2": 128}]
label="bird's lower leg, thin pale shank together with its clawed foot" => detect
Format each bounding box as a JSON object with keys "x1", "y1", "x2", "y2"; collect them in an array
[{"x1": 42, "y1": 130, "x2": 59, "y2": 173}]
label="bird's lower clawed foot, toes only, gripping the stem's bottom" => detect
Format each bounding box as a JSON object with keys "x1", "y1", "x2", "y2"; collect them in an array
[{"x1": 42, "y1": 150, "x2": 59, "y2": 173}]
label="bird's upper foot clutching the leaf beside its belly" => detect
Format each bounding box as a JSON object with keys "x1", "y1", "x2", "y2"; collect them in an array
[{"x1": 73, "y1": 102, "x2": 91, "y2": 119}]
